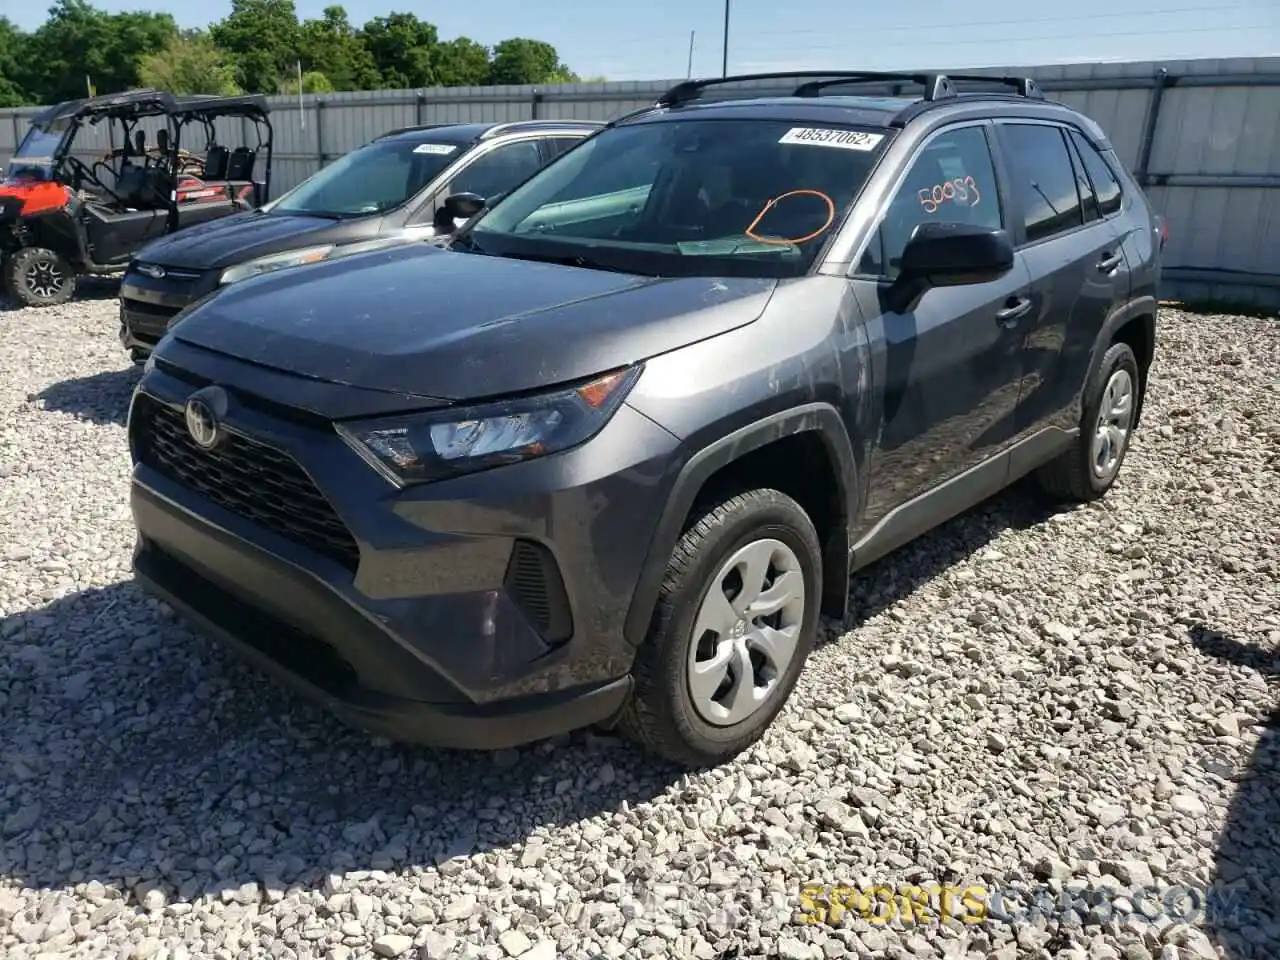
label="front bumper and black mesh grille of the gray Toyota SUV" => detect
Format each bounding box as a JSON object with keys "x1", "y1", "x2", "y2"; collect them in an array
[{"x1": 129, "y1": 353, "x2": 677, "y2": 749}]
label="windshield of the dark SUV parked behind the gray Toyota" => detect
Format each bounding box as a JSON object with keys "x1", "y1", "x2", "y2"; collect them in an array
[{"x1": 271, "y1": 140, "x2": 463, "y2": 216}]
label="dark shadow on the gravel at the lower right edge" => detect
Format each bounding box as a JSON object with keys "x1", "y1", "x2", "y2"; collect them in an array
[{"x1": 1189, "y1": 626, "x2": 1280, "y2": 960}]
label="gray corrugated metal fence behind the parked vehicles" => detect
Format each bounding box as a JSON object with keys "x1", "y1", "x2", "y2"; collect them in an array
[{"x1": 0, "y1": 58, "x2": 1280, "y2": 307}]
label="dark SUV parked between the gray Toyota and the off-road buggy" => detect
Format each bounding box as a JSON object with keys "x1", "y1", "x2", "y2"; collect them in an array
[{"x1": 120, "y1": 120, "x2": 603, "y2": 362}]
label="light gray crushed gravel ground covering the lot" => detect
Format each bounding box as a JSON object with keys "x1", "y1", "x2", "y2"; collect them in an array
[{"x1": 0, "y1": 289, "x2": 1280, "y2": 960}]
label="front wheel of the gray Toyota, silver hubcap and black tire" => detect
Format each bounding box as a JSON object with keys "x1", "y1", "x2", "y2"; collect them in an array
[{"x1": 618, "y1": 489, "x2": 822, "y2": 767}]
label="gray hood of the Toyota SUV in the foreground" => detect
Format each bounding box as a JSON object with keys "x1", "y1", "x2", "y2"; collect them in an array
[{"x1": 161, "y1": 243, "x2": 777, "y2": 401}]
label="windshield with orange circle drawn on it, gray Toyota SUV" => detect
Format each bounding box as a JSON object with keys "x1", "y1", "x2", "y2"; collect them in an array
[{"x1": 457, "y1": 119, "x2": 888, "y2": 278}]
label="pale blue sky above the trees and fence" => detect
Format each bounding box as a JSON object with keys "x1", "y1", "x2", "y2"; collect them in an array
[{"x1": 0, "y1": 0, "x2": 1280, "y2": 81}]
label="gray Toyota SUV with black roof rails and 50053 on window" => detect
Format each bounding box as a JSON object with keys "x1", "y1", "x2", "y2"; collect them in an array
[{"x1": 128, "y1": 72, "x2": 1164, "y2": 765}]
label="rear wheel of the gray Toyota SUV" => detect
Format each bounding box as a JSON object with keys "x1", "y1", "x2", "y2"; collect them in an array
[{"x1": 1034, "y1": 343, "x2": 1143, "y2": 503}]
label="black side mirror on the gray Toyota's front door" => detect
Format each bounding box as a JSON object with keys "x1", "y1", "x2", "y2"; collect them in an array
[{"x1": 893, "y1": 221, "x2": 1014, "y2": 312}]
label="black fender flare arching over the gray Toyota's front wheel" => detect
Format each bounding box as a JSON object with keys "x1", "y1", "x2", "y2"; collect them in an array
[{"x1": 623, "y1": 402, "x2": 858, "y2": 646}]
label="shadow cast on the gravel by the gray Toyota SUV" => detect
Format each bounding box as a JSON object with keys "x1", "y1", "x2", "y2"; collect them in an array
[{"x1": 0, "y1": 481, "x2": 1070, "y2": 902}]
